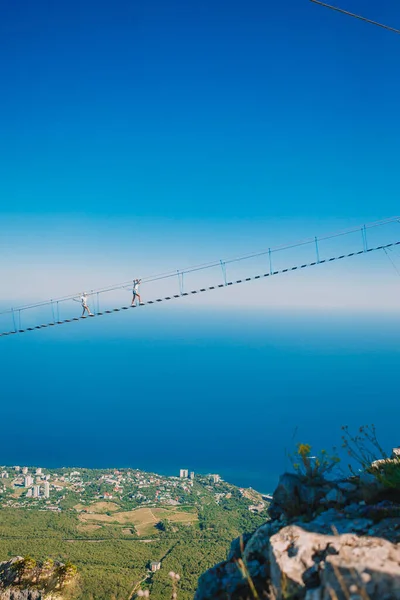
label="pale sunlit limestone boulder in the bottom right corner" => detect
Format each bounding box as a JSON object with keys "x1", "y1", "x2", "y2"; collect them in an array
[{"x1": 270, "y1": 526, "x2": 400, "y2": 600}]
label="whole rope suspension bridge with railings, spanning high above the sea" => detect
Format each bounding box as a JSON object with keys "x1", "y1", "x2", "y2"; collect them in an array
[{"x1": 0, "y1": 217, "x2": 400, "y2": 337}]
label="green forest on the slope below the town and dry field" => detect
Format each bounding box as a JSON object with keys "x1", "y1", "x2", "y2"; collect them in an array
[{"x1": 0, "y1": 478, "x2": 266, "y2": 600}]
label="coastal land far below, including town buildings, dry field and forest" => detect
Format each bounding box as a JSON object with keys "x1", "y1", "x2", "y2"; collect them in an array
[{"x1": 0, "y1": 465, "x2": 269, "y2": 600}]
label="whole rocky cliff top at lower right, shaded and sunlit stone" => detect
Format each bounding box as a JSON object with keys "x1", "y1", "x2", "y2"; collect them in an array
[{"x1": 195, "y1": 461, "x2": 400, "y2": 600}]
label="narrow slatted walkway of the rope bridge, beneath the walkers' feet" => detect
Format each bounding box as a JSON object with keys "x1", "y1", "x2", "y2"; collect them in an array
[{"x1": 0, "y1": 241, "x2": 400, "y2": 337}]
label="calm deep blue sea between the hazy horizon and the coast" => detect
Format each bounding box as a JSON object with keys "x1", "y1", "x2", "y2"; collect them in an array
[{"x1": 0, "y1": 306, "x2": 400, "y2": 493}]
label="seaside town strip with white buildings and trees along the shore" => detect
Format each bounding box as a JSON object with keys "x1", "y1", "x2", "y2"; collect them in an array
[{"x1": 0, "y1": 466, "x2": 269, "y2": 513}]
